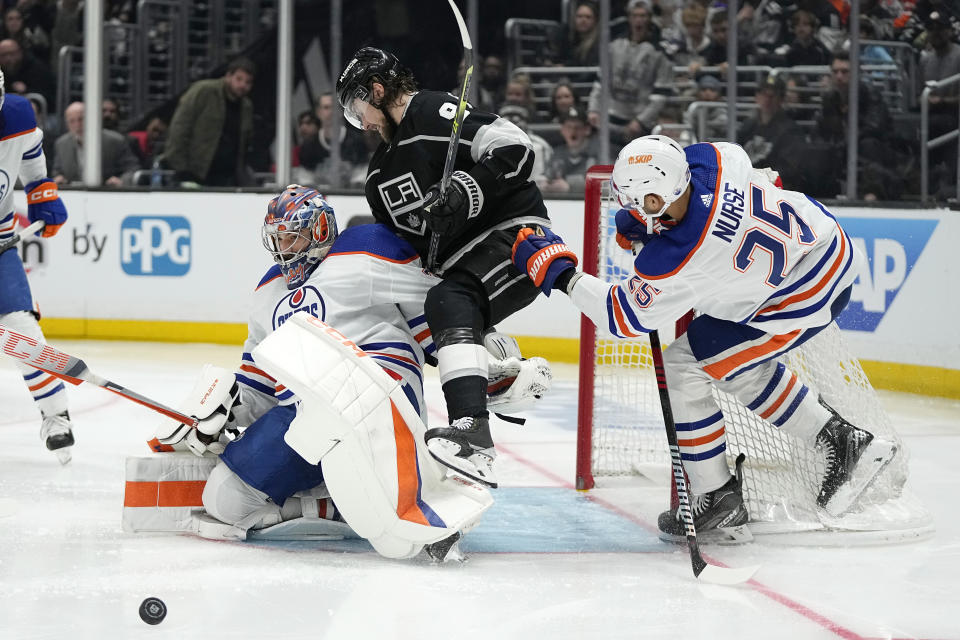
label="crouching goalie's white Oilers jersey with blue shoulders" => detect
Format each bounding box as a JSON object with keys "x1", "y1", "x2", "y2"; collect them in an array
[{"x1": 237, "y1": 224, "x2": 439, "y2": 421}]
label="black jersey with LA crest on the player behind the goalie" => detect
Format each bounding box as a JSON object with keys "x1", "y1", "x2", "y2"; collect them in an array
[{"x1": 365, "y1": 91, "x2": 547, "y2": 268}]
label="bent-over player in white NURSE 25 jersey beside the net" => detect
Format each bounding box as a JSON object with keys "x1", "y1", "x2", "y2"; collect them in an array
[{"x1": 514, "y1": 136, "x2": 896, "y2": 536}]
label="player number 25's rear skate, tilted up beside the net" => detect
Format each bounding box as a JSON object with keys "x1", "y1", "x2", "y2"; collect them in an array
[{"x1": 816, "y1": 409, "x2": 897, "y2": 517}]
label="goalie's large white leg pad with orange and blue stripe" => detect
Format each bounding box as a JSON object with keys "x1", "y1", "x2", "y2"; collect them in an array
[{"x1": 254, "y1": 314, "x2": 492, "y2": 558}]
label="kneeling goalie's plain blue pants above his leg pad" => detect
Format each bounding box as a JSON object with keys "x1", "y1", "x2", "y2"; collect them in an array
[{"x1": 220, "y1": 405, "x2": 323, "y2": 504}]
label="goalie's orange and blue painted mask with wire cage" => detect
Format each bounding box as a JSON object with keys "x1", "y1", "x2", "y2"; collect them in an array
[{"x1": 261, "y1": 184, "x2": 338, "y2": 289}]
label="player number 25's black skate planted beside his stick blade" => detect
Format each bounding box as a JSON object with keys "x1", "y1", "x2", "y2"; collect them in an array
[{"x1": 657, "y1": 454, "x2": 753, "y2": 544}]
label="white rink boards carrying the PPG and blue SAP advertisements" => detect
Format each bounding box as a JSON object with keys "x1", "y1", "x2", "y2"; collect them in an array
[{"x1": 9, "y1": 191, "x2": 960, "y2": 369}]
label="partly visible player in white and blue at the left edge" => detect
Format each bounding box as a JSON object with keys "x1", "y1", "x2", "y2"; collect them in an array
[{"x1": 0, "y1": 71, "x2": 74, "y2": 464}]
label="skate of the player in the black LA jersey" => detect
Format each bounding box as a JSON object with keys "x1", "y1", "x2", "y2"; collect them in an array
[{"x1": 425, "y1": 416, "x2": 497, "y2": 488}]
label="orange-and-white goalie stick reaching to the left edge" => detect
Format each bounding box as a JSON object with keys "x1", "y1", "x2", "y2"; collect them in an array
[{"x1": 0, "y1": 324, "x2": 198, "y2": 427}]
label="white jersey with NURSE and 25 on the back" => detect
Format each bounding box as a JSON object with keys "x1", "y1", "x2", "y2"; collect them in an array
[{"x1": 570, "y1": 143, "x2": 863, "y2": 338}]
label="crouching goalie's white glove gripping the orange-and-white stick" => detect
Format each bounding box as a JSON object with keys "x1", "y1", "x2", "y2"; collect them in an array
[{"x1": 150, "y1": 364, "x2": 240, "y2": 456}]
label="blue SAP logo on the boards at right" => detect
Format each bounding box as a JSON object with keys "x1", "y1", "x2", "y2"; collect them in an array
[{"x1": 837, "y1": 218, "x2": 937, "y2": 331}]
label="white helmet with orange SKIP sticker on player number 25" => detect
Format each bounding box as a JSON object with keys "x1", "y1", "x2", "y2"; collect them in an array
[{"x1": 610, "y1": 136, "x2": 690, "y2": 233}]
